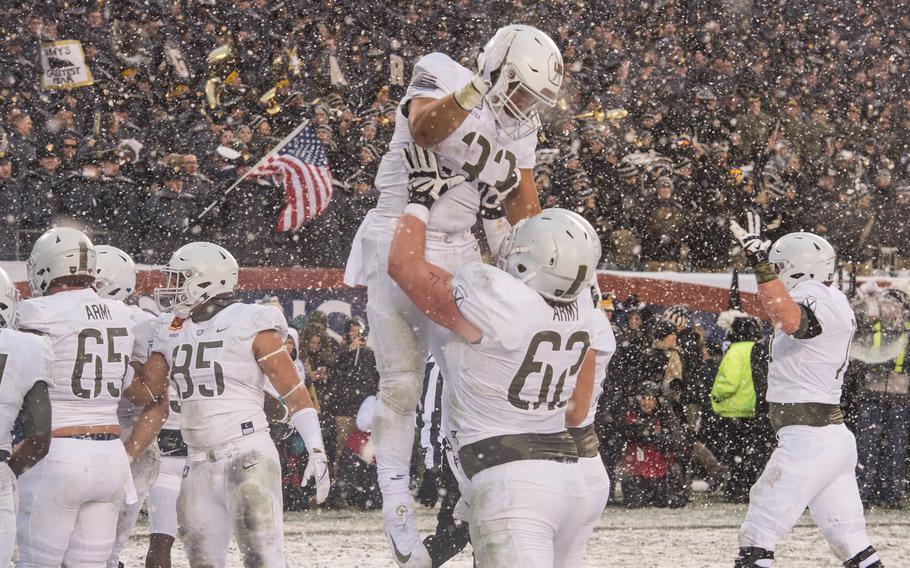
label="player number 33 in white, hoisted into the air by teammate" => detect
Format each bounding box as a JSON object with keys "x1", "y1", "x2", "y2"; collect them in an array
[{"x1": 345, "y1": 25, "x2": 563, "y2": 566}]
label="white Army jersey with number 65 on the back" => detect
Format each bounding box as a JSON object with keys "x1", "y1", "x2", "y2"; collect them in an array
[{"x1": 19, "y1": 288, "x2": 135, "y2": 429}]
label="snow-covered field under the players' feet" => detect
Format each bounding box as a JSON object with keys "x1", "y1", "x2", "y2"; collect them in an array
[{"x1": 121, "y1": 496, "x2": 910, "y2": 568}]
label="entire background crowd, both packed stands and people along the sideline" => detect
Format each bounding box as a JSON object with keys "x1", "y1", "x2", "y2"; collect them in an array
[{"x1": 0, "y1": 0, "x2": 910, "y2": 508}]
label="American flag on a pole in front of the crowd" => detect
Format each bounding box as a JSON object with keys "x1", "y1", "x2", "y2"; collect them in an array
[{"x1": 250, "y1": 123, "x2": 332, "y2": 231}]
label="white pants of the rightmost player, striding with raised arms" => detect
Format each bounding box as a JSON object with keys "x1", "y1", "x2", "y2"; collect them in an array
[{"x1": 739, "y1": 424, "x2": 869, "y2": 562}]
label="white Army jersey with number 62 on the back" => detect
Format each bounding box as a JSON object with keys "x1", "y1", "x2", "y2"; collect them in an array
[{"x1": 437, "y1": 262, "x2": 605, "y2": 450}]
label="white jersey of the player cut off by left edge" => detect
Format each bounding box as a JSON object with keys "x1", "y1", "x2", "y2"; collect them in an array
[{"x1": 0, "y1": 329, "x2": 54, "y2": 452}]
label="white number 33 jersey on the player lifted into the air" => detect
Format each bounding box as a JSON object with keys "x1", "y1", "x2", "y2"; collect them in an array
[{"x1": 375, "y1": 53, "x2": 537, "y2": 233}]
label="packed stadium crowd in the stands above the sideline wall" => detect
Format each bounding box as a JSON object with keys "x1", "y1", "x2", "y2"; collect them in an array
[{"x1": 0, "y1": 0, "x2": 910, "y2": 272}]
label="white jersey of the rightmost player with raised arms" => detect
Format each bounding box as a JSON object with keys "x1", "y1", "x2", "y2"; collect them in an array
[{"x1": 767, "y1": 280, "x2": 856, "y2": 404}]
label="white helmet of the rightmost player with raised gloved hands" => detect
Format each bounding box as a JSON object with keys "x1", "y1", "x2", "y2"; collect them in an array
[{"x1": 768, "y1": 233, "x2": 837, "y2": 290}]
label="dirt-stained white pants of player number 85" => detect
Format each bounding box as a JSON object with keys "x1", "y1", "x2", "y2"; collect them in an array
[{"x1": 177, "y1": 431, "x2": 285, "y2": 568}]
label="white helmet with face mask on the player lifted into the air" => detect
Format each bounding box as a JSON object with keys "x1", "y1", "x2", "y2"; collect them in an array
[{"x1": 477, "y1": 24, "x2": 563, "y2": 140}]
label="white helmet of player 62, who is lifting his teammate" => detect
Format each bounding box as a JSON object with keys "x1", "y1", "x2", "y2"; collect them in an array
[{"x1": 497, "y1": 209, "x2": 600, "y2": 302}]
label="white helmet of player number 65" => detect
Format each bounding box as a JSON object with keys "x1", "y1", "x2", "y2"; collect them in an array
[{"x1": 26, "y1": 227, "x2": 96, "y2": 296}]
